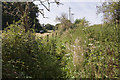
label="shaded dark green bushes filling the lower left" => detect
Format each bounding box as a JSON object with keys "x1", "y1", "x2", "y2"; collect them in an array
[{"x1": 2, "y1": 22, "x2": 65, "y2": 78}]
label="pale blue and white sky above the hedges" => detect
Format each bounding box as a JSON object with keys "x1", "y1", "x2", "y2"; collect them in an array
[{"x1": 35, "y1": 0, "x2": 102, "y2": 25}]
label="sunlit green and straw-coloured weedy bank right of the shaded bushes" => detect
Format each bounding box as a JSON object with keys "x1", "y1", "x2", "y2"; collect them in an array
[{"x1": 58, "y1": 24, "x2": 120, "y2": 79}]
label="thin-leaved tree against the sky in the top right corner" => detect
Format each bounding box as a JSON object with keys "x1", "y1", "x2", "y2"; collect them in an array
[{"x1": 97, "y1": 0, "x2": 120, "y2": 23}]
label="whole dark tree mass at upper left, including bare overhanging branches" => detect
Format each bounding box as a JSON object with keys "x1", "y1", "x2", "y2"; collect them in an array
[{"x1": 2, "y1": 0, "x2": 60, "y2": 32}]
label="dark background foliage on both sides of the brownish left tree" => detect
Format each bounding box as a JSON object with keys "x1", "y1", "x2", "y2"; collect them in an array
[{"x1": 2, "y1": 2, "x2": 42, "y2": 29}]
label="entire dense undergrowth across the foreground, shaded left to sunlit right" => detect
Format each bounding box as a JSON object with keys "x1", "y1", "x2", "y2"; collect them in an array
[{"x1": 2, "y1": 22, "x2": 120, "y2": 78}]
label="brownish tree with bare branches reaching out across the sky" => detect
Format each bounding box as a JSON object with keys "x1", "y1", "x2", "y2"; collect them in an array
[{"x1": 4, "y1": 0, "x2": 60, "y2": 32}]
